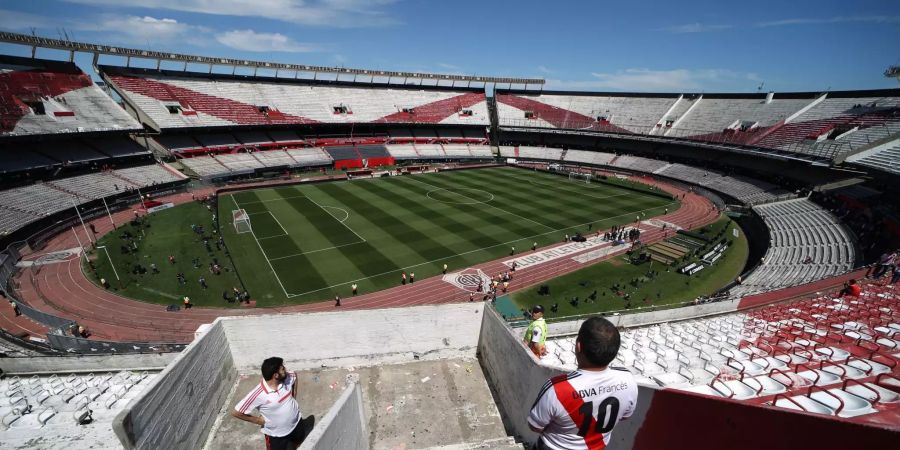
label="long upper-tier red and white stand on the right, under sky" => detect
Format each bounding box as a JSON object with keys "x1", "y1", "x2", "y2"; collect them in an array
[{"x1": 496, "y1": 90, "x2": 900, "y2": 160}]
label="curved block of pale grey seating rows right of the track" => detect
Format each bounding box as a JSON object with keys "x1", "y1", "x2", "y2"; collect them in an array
[{"x1": 730, "y1": 199, "x2": 856, "y2": 296}]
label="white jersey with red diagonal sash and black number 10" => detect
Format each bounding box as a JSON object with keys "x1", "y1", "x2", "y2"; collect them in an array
[{"x1": 528, "y1": 368, "x2": 637, "y2": 450}]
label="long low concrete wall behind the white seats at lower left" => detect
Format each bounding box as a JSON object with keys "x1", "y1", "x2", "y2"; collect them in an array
[{"x1": 0, "y1": 353, "x2": 178, "y2": 375}]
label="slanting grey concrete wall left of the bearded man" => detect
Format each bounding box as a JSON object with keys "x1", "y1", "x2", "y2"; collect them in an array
[{"x1": 113, "y1": 319, "x2": 237, "y2": 450}]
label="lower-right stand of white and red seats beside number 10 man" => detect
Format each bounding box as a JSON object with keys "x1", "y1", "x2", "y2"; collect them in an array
[{"x1": 542, "y1": 284, "x2": 900, "y2": 421}]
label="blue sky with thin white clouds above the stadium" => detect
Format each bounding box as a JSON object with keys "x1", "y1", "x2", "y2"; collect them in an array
[{"x1": 0, "y1": 0, "x2": 900, "y2": 92}]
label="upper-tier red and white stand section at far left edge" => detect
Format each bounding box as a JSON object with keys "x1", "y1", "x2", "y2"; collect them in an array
[{"x1": 0, "y1": 56, "x2": 141, "y2": 136}]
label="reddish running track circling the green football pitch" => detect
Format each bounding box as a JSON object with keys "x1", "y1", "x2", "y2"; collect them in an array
[{"x1": 7, "y1": 177, "x2": 719, "y2": 343}]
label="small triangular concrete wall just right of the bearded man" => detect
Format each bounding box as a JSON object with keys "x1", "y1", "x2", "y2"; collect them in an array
[{"x1": 300, "y1": 383, "x2": 369, "y2": 450}]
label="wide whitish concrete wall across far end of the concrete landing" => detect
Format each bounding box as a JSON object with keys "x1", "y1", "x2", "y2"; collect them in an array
[{"x1": 219, "y1": 303, "x2": 484, "y2": 373}]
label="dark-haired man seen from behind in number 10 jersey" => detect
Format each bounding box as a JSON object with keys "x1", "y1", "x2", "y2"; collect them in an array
[{"x1": 528, "y1": 317, "x2": 637, "y2": 450}]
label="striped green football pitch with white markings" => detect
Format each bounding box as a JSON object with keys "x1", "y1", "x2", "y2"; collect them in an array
[{"x1": 219, "y1": 168, "x2": 678, "y2": 305}]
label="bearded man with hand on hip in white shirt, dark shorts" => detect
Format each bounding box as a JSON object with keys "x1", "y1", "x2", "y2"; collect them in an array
[{"x1": 231, "y1": 358, "x2": 305, "y2": 450}]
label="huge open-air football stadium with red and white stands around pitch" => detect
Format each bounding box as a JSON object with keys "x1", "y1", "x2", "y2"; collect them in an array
[{"x1": 0, "y1": 1, "x2": 900, "y2": 449}]
